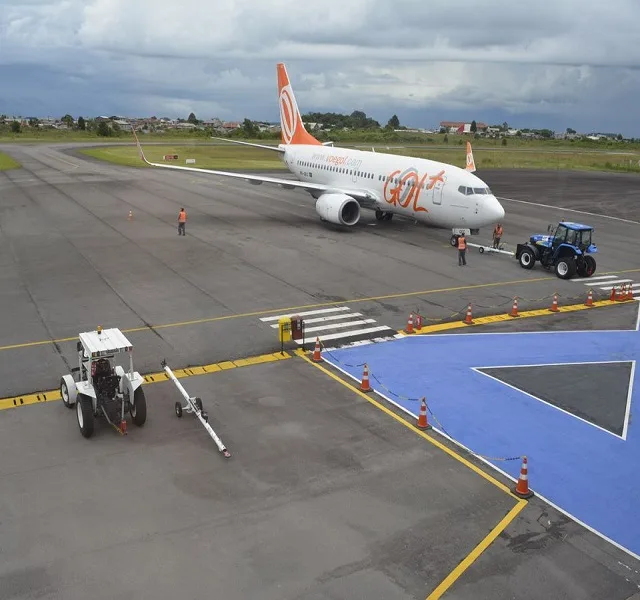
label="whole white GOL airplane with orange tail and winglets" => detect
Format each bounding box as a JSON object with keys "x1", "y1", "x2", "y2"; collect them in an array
[{"x1": 131, "y1": 63, "x2": 505, "y2": 245}]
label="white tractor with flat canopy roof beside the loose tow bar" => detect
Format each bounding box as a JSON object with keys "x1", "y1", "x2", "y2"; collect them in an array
[{"x1": 60, "y1": 327, "x2": 147, "y2": 438}]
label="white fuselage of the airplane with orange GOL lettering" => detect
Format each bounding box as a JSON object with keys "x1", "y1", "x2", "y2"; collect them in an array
[{"x1": 282, "y1": 144, "x2": 504, "y2": 229}]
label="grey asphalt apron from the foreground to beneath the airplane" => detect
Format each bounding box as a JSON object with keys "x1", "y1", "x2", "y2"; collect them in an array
[{"x1": 0, "y1": 144, "x2": 640, "y2": 600}]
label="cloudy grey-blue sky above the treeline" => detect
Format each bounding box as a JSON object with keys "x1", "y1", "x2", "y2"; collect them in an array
[{"x1": 0, "y1": 0, "x2": 640, "y2": 137}]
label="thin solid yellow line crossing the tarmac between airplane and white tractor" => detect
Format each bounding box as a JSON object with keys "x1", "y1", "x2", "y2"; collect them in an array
[{"x1": 5, "y1": 269, "x2": 640, "y2": 351}]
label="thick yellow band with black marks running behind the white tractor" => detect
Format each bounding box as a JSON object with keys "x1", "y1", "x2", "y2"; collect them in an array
[{"x1": 0, "y1": 352, "x2": 291, "y2": 410}]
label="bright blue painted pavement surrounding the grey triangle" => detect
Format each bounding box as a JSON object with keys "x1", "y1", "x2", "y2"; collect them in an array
[{"x1": 323, "y1": 331, "x2": 640, "y2": 557}]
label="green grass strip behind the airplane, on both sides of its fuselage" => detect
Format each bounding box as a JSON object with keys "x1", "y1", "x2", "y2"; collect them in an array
[{"x1": 80, "y1": 144, "x2": 640, "y2": 173}]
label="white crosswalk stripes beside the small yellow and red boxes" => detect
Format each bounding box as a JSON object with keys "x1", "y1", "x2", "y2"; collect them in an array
[{"x1": 260, "y1": 306, "x2": 397, "y2": 345}]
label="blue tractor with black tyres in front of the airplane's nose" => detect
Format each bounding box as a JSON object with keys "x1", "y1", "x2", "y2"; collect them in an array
[{"x1": 515, "y1": 221, "x2": 598, "y2": 279}]
